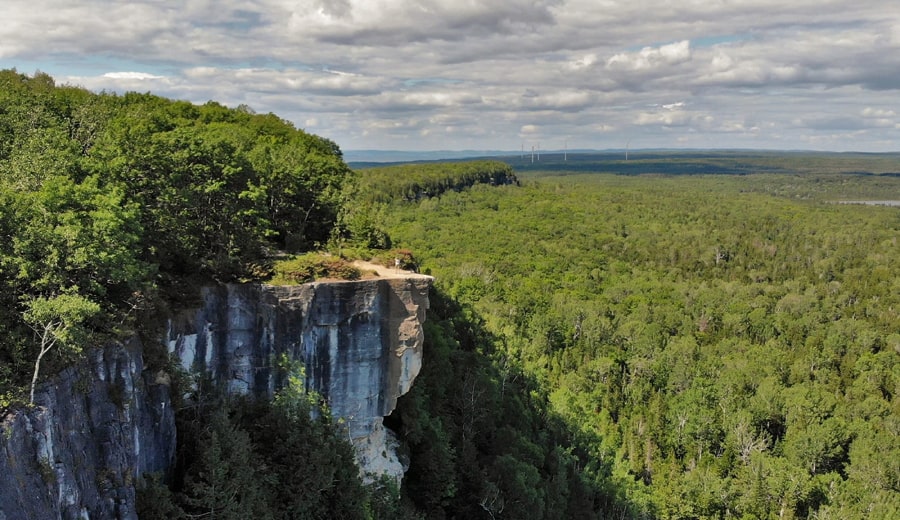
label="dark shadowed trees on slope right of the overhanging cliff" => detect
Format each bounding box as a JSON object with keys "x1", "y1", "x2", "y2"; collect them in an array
[{"x1": 385, "y1": 289, "x2": 637, "y2": 518}]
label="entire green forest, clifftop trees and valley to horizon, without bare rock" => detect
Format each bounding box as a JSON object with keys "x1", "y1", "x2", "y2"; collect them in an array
[{"x1": 0, "y1": 70, "x2": 900, "y2": 519}]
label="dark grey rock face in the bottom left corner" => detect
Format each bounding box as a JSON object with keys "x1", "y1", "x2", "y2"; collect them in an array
[{"x1": 0, "y1": 343, "x2": 176, "y2": 520}]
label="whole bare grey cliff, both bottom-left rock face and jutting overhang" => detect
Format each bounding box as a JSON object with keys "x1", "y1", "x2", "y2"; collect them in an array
[{"x1": 0, "y1": 275, "x2": 431, "y2": 520}]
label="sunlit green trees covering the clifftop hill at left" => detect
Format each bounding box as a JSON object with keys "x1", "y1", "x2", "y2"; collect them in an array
[{"x1": 0, "y1": 70, "x2": 353, "y2": 407}]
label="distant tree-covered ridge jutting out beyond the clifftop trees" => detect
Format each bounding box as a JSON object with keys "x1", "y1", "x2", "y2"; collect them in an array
[{"x1": 359, "y1": 161, "x2": 517, "y2": 202}]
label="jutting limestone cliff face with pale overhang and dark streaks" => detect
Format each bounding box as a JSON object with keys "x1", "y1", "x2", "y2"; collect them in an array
[{"x1": 168, "y1": 275, "x2": 431, "y2": 481}]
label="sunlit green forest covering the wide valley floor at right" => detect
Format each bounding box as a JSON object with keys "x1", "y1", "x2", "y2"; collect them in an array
[{"x1": 380, "y1": 161, "x2": 900, "y2": 518}]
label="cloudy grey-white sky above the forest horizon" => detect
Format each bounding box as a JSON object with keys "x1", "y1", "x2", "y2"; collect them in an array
[{"x1": 0, "y1": 0, "x2": 900, "y2": 152}]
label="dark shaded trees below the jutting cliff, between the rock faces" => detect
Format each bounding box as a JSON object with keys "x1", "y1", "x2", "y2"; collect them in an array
[{"x1": 138, "y1": 372, "x2": 384, "y2": 520}]
